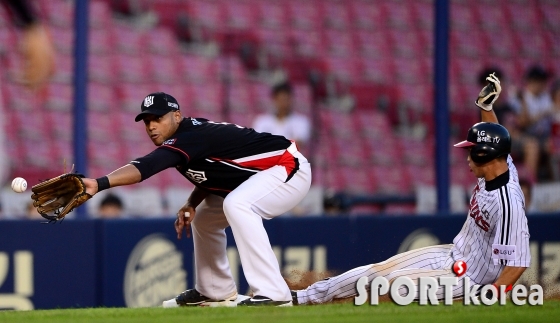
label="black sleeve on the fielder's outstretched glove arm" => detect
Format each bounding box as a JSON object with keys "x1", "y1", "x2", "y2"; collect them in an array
[{"x1": 130, "y1": 149, "x2": 185, "y2": 180}]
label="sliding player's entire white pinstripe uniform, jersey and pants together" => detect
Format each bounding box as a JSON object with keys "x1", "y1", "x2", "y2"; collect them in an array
[{"x1": 297, "y1": 156, "x2": 531, "y2": 304}]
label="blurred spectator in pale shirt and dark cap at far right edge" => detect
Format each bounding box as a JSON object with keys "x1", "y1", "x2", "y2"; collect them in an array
[{"x1": 514, "y1": 65, "x2": 552, "y2": 140}]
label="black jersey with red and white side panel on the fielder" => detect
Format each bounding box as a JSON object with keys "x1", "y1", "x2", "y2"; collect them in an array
[{"x1": 153, "y1": 118, "x2": 298, "y2": 197}]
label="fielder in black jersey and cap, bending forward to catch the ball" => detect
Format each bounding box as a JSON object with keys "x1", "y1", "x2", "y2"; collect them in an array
[{"x1": 84, "y1": 92, "x2": 311, "y2": 307}]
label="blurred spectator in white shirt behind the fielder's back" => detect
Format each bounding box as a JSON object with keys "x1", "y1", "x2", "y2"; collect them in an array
[{"x1": 253, "y1": 83, "x2": 311, "y2": 150}]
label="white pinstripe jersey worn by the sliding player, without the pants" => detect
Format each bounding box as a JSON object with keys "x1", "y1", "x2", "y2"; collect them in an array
[{"x1": 451, "y1": 156, "x2": 531, "y2": 284}]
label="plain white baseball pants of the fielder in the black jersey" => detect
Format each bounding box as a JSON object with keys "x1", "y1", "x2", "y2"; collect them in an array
[{"x1": 192, "y1": 151, "x2": 311, "y2": 301}]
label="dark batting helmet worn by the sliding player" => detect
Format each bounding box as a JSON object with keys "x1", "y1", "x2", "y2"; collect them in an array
[{"x1": 454, "y1": 122, "x2": 511, "y2": 164}]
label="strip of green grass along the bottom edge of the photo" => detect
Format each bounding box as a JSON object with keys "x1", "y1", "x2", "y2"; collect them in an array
[{"x1": 0, "y1": 300, "x2": 560, "y2": 323}]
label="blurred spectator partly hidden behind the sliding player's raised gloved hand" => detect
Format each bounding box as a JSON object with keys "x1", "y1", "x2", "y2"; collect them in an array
[{"x1": 478, "y1": 67, "x2": 540, "y2": 180}]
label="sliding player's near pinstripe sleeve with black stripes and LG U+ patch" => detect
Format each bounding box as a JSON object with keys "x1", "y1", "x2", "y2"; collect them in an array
[{"x1": 492, "y1": 182, "x2": 531, "y2": 267}]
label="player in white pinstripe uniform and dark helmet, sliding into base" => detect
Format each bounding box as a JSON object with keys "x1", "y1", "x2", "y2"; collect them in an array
[{"x1": 292, "y1": 75, "x2": 531, "y2": 304}]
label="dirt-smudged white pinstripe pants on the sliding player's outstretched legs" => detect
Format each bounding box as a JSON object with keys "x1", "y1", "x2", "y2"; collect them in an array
[{"x1": 297, "y1": 244, "x2": 474, "y2": 304}]
